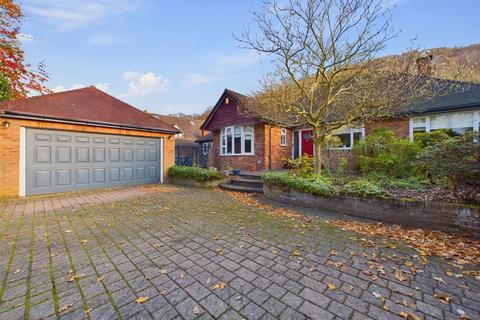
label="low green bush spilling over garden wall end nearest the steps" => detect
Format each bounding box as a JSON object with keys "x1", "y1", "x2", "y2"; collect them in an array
[{"x1": 262, "y1": 172, "x2": 335, "y2": 196}]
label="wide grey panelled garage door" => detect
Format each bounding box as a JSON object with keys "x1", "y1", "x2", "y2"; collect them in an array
[{"x1": 25, "y1": 129, "x2": 161, "y2": 195}]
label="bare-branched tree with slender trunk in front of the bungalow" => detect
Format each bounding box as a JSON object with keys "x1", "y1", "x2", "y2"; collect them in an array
[{"x1": 236, "y1": 0, "x2": 468, "y2": 174}]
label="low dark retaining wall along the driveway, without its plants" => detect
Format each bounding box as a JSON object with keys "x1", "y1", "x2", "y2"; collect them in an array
[{"x1": 263, "y1": 183, "x2": 480, "y2": 237}]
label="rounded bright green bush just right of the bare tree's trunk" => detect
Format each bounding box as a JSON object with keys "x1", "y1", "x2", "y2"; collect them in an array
[{"x1": 353, "y1": 128, "x2": 422, "y2": 178}]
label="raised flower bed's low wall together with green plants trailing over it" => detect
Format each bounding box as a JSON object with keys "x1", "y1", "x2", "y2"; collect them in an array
[{"x1": 263, "y1": 173, "x2": 480, "y2": 236}]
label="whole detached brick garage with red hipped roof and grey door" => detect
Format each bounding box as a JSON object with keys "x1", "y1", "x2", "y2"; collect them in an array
[{"x1": 0, "y1": 86, "x2": 180, "y2": 196}]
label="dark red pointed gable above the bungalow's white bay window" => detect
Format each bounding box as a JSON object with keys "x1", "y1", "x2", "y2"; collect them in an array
[{"x1": 201, "y1": 90, "x2": 261, "y2": 131}]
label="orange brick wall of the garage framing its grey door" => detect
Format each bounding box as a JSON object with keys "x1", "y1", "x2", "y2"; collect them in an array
[{"x1": 0, "y1": 118, "x2": 175, "y2": 197}]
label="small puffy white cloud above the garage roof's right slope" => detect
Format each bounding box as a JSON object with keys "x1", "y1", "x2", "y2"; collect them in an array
[{"x1": 122, "y1": 70, "x2": 170, "y2": 96}]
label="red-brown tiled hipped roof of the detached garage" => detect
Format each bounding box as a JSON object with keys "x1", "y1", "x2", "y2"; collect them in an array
[{"x1": 0, "y1": 86, "x2": 180, "y2": 133}]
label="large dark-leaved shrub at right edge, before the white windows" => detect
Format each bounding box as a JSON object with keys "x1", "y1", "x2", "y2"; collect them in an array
[{"x1": 416, "y1": 134, "x2": 480, "y2": 202}]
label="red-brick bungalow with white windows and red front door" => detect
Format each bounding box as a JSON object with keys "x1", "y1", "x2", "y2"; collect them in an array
[{"x1": 201, "y1": 83, "x2": 480, "y2": 171}]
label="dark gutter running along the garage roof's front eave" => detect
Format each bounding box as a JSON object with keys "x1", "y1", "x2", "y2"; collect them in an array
[{"x1": 0, "y1": 110, "x2": 181, "y2": 134}]
